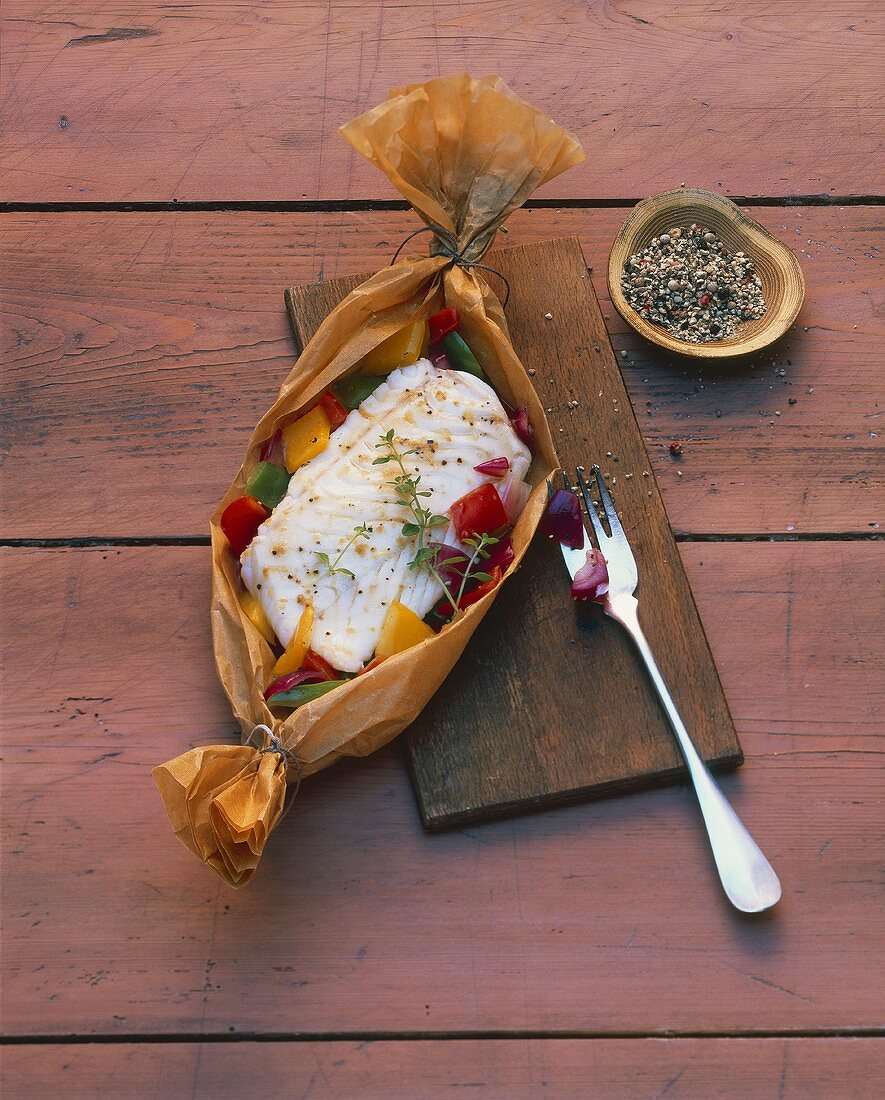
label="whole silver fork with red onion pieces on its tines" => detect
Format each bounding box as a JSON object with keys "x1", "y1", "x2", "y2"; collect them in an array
[{"x1": 562, "y1": 466, "x2": 781, "y2": 913}]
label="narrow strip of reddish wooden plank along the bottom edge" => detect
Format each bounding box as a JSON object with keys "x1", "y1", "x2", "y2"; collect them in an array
[{"x1": 3, "y1": 1038, "x2": 885, "y2": 1100}]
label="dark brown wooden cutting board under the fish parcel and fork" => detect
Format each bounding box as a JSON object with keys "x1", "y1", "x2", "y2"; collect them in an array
[{"x1": 286, "y1": 238, "x2": 743, "y2": 829}]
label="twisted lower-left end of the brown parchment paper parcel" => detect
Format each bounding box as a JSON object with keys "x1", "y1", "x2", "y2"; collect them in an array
[{"x1": 152, "y1": 727, "x2": 289, "y2": 888}]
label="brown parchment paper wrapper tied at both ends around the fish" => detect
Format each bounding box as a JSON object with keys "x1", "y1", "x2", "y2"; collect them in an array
[{"x1": 153, "y1": 75, "x2": 584, "y2": 887}]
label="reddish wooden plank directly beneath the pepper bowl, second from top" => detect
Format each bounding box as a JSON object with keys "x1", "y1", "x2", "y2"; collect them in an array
[{"x1": 0, "y1": 208, "x2": 885, "y2": 538}]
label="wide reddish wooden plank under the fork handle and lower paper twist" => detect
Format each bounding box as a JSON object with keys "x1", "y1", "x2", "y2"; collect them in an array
[{"x1": 0, "y1": 543, "x2": 885, "y2": 1036}]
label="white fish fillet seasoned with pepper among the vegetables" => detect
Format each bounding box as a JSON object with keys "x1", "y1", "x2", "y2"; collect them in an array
[{"x1": 241, "y1": 359, "x2": 531, "y2": 672}]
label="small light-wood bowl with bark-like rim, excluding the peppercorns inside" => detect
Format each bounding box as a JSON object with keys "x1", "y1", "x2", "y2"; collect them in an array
[{"x1": 608, "y1": 187, "x2": 805, "y2": 359}]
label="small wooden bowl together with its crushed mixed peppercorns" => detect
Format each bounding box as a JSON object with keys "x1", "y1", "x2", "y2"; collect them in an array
[{"x1": 608, "y1": 188, "x2": 805, "y2": 359}]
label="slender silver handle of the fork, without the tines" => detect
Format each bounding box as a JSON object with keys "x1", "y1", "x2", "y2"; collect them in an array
[{"x1": 605, "y1": 594, "x2": 781, "y2": 913}]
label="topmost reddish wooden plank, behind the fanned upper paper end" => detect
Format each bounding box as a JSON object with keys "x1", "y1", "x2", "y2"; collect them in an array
[{"x1": 0, "y1": 0, "x2": 882, "y2": 201}]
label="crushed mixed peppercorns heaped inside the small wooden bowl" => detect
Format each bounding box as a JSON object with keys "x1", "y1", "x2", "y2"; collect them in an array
[{"x1": 621, "y1": 224, "x2": 765, "y2": 343}]
